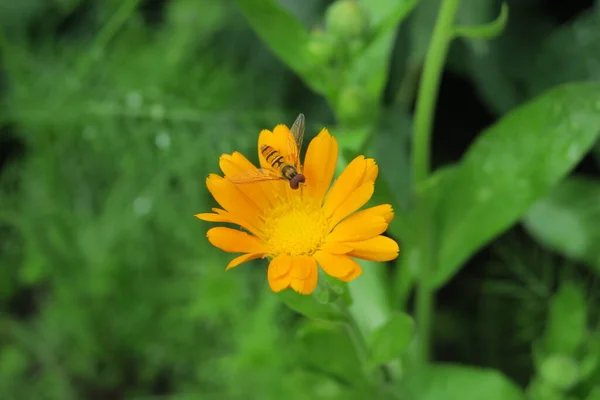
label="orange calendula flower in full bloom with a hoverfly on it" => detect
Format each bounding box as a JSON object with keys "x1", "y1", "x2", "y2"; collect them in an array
[{"x1": 196, "y1": 119, "x2": 399, "y2": 294}]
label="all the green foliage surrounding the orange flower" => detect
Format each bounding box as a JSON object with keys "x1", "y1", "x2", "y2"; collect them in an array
[{"x1": 0, "y1": 0, "x2": 600, "y2": 400}]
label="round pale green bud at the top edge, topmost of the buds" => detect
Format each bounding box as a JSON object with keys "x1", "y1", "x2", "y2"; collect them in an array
[{"x1": 325, "y1": 0, "x2": 369, "y2": 40}]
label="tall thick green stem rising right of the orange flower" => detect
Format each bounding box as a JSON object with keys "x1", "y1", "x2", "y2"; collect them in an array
[{"x1": 412, "y1": 0, "x2": 460, "y2": 367}]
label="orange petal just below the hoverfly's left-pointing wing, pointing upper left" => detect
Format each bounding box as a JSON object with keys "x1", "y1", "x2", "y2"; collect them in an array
[{"x1": 206, "y1": 174, "x2": 262, "y2": 232}]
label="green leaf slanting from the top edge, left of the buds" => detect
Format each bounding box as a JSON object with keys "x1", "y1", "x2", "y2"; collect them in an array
[{"x1": 236, "y1": 0, "x2": 327, "y2": 93}]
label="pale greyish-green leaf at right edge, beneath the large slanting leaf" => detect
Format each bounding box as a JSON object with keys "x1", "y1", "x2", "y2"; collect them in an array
[{"x1": 524, "y1": 177, "x2": 600, "y2": 273}]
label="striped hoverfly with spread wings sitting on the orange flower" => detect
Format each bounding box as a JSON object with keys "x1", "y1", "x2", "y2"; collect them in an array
[{"x1": 228, "y1": 113, "x2": 306, "y2": 190}]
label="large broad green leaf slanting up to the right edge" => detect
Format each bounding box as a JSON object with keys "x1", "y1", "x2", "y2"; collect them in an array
[{"x1": 433, "y1": 84, "x2": 600, "y2": 287}]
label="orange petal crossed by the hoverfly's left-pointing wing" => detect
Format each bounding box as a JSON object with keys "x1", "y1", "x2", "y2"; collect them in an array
[{"x1": 219, "y1": 151, "x2": 273, "y2": 209}]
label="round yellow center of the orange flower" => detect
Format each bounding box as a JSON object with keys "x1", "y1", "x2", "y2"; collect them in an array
[{"x1": 264, "y1": 196, "x2": 329, "y2": 256}]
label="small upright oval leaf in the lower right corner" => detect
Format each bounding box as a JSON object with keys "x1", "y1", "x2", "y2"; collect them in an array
[{"x1": 544, "y1": 283, "x2": 587, "y2": 355}]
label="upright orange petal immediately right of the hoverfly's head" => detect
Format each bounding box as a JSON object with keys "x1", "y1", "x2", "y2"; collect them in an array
[{"x1": 303, "y1": 129, "x2": 338, "y2": 204}]
